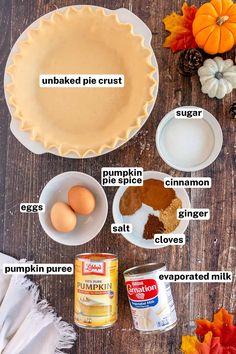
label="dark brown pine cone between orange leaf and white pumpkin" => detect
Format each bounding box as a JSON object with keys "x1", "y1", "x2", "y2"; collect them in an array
[{"x1": 178, "y1": 49, "x2": 203, "y2": 76}]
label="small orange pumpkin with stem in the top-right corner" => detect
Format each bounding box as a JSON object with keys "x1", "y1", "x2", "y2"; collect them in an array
[{"x1": 193, "y1": 0, "x2": 236, "y2": 54}]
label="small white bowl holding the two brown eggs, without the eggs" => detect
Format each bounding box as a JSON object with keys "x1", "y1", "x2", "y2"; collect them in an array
[{"x1": 39, "y1": 171, "x2": 108, "y2": 246}]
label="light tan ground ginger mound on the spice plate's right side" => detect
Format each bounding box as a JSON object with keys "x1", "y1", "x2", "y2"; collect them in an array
[{"x1": 160, "y1": 198, "x2": 182, "y2": 234}]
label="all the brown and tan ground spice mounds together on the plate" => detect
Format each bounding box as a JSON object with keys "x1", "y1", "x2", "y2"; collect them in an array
[{"x1": 119, "y1": 179, "x2": 182, "y2": 239}]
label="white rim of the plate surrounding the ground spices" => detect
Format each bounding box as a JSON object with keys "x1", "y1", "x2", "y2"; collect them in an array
[{"x1": 112, "y1": 171, "x2": 191, "y2": 249}]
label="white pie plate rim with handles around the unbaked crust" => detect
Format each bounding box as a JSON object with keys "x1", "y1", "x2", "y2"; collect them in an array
[{"x1": 4, "y1": 6, "x2": 159, "y2": 158}]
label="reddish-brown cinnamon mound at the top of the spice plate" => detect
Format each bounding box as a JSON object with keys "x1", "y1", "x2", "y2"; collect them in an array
[{"x1": 141, "y1": 179, "x2": 176, "y2": 210}]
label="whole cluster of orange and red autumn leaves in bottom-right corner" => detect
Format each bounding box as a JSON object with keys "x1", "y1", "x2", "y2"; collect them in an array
[{"x1": 181, "y1": 308, "x2": 236, "y2": 354}]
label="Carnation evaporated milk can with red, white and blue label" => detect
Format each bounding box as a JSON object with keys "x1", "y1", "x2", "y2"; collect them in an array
[{"x1": 124, "y1": 263, "x2": 177, "y2": 333}]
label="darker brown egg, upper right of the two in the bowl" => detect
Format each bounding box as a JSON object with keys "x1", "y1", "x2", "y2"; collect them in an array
[{"x1": 68, "y1": 186, "x2": 96, "y2": 215}]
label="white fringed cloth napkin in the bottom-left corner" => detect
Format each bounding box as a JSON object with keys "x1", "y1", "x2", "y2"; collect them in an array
[{"x1": 0, "y1": 253, "x2": 76, "y2": 354}]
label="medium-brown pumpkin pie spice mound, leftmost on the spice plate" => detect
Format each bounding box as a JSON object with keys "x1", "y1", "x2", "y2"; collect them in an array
[{"x1": 119, "y1": 187, "x2": 142, "y2": 215}]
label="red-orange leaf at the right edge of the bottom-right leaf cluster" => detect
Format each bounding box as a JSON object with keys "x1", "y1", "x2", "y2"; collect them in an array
[{"x1": 196, "y1": 308, "x2": 236, "y2": 353}]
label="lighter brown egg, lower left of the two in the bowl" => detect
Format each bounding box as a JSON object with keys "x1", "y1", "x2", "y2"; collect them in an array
[{"x1": 50, "y1": 202, "x2": 77, "y2": 232}]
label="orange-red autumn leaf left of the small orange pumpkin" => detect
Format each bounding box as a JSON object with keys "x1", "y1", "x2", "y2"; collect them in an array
[{"x1": 163, "y1": 2, "x2": 197, "y2": 52}]
